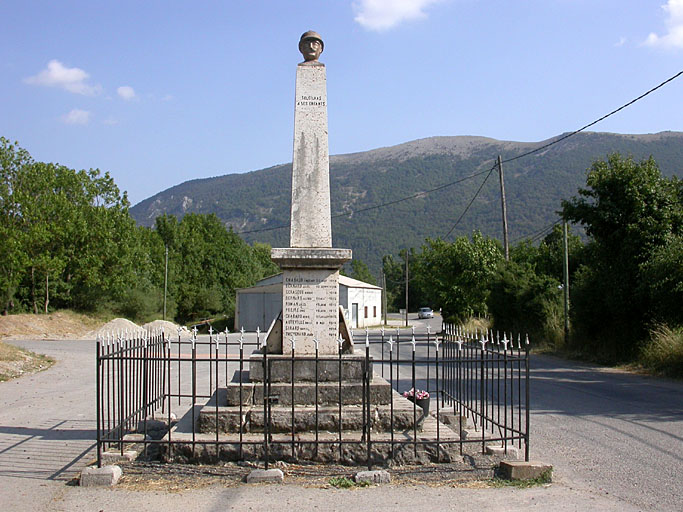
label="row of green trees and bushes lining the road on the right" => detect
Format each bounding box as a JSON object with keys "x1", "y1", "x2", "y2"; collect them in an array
[{"x1": 383, "y1": 154, "x2": 683, "y2": 378}]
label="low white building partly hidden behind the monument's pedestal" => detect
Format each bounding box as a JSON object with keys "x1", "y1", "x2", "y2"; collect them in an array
[{"x1": 235, "y1": 274, "x2": 382, "y2": 331}]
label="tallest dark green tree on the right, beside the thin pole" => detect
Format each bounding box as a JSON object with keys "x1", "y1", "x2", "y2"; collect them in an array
[{"x1": 562, "y1": 154, "x2": 683, "y2": 360}]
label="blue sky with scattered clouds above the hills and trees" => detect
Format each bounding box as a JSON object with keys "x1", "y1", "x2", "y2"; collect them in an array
[{"x1": 0, "y1": 0, "x2": 683, "y2": 204}]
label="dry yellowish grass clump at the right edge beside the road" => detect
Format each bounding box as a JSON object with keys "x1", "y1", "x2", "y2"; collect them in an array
[{"x1": 638, "y1": 325, "x2": 683, "y2": 379}]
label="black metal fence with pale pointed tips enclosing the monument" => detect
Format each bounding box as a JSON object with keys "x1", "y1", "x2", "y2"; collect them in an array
[{"x1": 97, "y1": 324, "x2": 529, "y2": 468}]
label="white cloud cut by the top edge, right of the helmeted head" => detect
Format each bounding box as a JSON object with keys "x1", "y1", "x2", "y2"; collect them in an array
[{"x1": 353, "y1": 0, "x2": 441, "y2": 31}]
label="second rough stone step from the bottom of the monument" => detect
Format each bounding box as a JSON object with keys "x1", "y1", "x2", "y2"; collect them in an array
[{"x1": 197, "y1": 406, "x2": 423, "y2": 433}]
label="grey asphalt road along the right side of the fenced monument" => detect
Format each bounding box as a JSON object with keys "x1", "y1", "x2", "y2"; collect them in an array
[{"x1": 388, "y1": 318, "x2": 683, "y2": 511}]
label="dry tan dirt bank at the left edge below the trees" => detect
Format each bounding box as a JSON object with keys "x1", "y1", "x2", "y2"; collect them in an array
[{"x1": 0, "y1": 311, "x2": 102, "y2": 340}]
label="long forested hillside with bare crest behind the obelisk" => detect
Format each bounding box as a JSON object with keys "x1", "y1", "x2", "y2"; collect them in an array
[{"x1": 131, "y1": 132, "x2": 683, "y2": 273}]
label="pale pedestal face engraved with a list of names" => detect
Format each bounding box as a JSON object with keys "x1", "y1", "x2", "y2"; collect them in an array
[{"x1": 282, "y1": 269, "x2": 339, "y2": 355}]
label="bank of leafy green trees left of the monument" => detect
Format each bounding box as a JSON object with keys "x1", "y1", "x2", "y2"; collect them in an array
[{"x1": 0, "y1": 137, "x2": 277, "y2": 323}]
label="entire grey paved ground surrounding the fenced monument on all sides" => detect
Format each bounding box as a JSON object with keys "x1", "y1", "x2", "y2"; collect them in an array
[{"x1": 0, "y1": 319, "x2": 683, "y2": 512}]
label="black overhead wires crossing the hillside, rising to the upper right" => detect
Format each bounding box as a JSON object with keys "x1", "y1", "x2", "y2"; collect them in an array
[{"x1": 236, "y1": 70, "x2": 683, "y2": 238}]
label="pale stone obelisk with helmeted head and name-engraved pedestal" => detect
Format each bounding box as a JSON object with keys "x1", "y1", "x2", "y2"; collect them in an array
[{"x1": 271, "y1": 31, "x2": 351, "y2": 355}]
